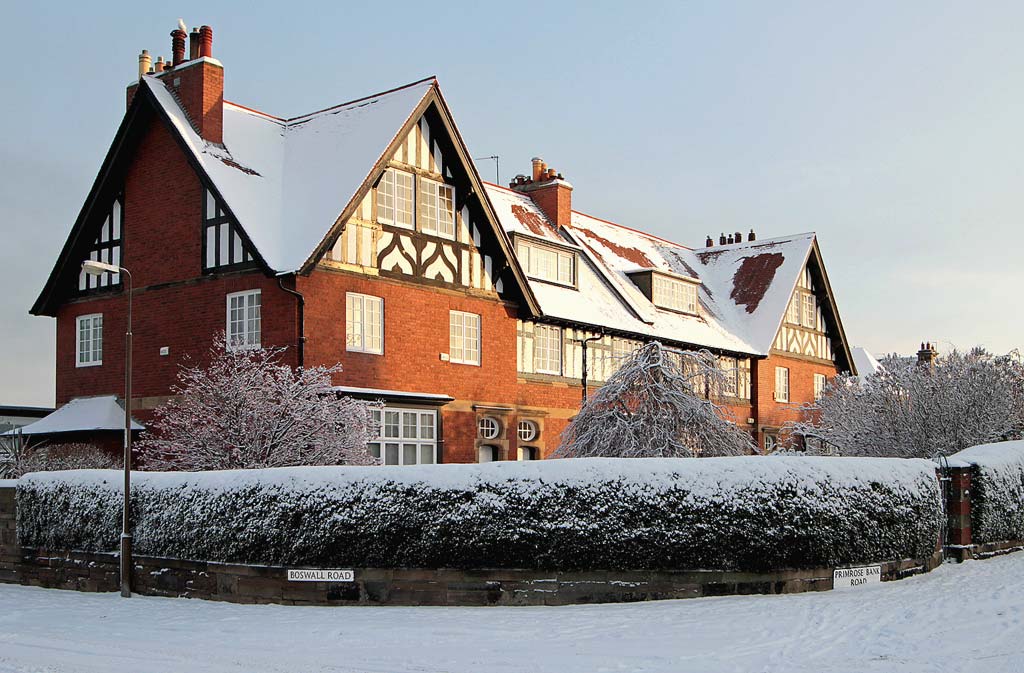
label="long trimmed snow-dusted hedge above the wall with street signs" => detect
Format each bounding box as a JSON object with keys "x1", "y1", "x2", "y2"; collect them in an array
[{"x1": 17, "y1": 456, "x2": 942, "y2": 572}]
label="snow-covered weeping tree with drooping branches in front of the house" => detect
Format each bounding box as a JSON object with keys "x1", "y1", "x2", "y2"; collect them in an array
[{"x1": 554, "y1": 341, "x2": 754, "y2": 458}]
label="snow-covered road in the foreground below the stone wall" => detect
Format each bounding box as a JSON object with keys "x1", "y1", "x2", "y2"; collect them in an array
[{"x1": 0, "y1": 553, "x2": 1024, "y2": 673}]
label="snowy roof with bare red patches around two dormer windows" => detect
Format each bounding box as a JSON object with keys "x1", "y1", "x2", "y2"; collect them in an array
[{"x1": 486, "y1": 184, "x2": 814, "y2": 354}]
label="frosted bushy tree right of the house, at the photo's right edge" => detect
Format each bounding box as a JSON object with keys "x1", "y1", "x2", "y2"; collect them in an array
[{"x1": 791, "y1": 348, "x2": 1024, "y2": 458}]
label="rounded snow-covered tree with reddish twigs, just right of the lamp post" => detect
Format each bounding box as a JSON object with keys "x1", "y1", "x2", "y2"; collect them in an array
[{"x1": 139, "y1": 335, "x2": 377, "y2": 470}]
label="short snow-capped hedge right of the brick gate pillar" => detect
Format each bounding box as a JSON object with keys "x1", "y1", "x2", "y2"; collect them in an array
[{"x1": 949, "y1": 441, "x2": 1024, "y2": 544}]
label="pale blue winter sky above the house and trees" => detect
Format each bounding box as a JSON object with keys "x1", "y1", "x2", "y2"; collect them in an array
[{"x1": 0, "y1": 0, "x2": 1024, "y2": 406}]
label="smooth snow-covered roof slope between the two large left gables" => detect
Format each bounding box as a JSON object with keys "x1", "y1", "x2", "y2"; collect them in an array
[{"x1": 140, "y1": 76, "x2": 434, "y2": 274}]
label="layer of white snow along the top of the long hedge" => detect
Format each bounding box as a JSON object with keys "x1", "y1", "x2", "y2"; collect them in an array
[{"x1": 20, "y1": 456, "x2": 935, "y2": 499}]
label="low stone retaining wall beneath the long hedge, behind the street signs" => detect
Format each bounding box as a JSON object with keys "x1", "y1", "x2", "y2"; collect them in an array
[{"x1": 4, "y1": 548, "x2": 941, "y2": 605}]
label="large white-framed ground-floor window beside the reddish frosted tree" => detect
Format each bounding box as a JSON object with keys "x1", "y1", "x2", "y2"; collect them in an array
[{"x1": 367, "y1": 407, "x2": 437, "y2": 465}]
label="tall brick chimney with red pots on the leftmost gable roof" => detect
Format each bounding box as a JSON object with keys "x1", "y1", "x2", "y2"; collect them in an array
[{"x1": 128, "y1": 23, "x2": 224, "y2": 143}]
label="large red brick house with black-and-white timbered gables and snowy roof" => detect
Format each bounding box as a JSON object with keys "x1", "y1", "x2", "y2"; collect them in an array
[{"x1": 25, "y1": 22, "x2": 854, "y2": 464}]
